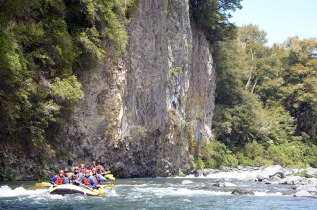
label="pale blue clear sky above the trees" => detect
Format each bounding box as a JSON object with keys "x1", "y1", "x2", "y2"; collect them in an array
[{"x1": 230, "y1": 0, "x2": 317, "y2": 46}]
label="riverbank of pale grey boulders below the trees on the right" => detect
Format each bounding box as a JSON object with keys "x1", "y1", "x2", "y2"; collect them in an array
[{"x1": 187, "y1": 165, "x2": 317, "y2": 198}]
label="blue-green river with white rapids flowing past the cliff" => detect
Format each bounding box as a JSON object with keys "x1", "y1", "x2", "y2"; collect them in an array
[{"x1": 0, "y1": 171, "x2": 317, "y2": 209}]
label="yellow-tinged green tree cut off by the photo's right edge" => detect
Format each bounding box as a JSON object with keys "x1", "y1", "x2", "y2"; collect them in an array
[{"x1": 281, "y1": 37, "x2": 317, "y2": 143}]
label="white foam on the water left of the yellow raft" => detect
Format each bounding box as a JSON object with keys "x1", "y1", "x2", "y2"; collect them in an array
[{"x1": 0, "y1": 185, "x2": 47, "y2": 197}]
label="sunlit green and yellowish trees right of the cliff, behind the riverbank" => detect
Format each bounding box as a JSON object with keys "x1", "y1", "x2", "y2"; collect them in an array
[{"x1": 200, "y1": 25, "x2": 317, "y2": 167}]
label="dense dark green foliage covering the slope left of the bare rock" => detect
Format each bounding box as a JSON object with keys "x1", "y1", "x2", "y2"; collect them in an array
[{"x1": 0, "y1": 0, "x2": 130, "y2": 147}]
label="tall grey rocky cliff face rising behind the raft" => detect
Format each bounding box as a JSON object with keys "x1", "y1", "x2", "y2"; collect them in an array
[{"x1": 62, "y1": 0, "x2": 215, "y2": 177}]
